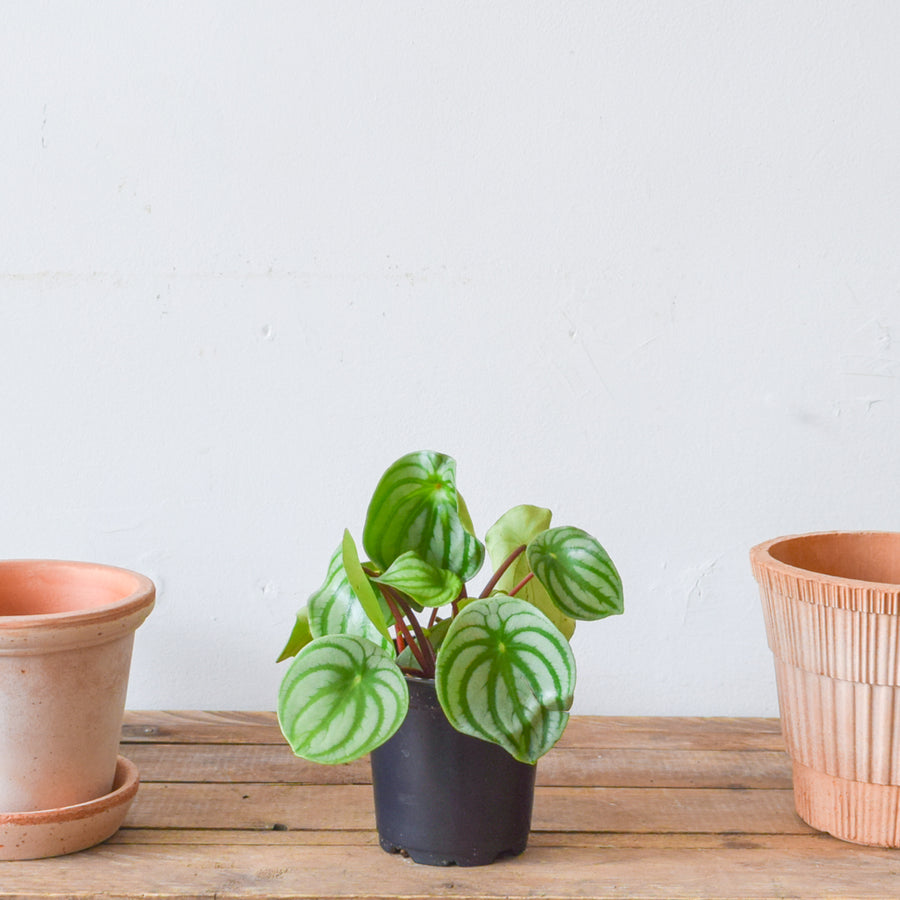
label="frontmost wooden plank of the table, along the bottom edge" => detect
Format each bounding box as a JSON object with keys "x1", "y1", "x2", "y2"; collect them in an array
[{"x1": 0, "y1": 844, "x2": 900, "y2": 900}]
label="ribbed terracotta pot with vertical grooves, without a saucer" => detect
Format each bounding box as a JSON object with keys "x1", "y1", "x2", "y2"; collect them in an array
[{"x1": 750, "y1": 532, "x2": 900, "y2": 847}]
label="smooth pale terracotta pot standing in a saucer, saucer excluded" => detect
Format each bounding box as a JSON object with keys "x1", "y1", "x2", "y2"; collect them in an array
[{"x1": 0, "y1": 560, "x2": 155, "y2": 858}]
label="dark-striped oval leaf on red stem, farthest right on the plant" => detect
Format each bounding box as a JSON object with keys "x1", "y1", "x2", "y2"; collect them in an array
[{"x1": 526, "y1": 525, "x2": 624, "y2": 620}]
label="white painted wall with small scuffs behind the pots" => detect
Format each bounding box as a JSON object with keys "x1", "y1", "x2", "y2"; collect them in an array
[{"x1": 0, "y1": 0, "x2": 900, "y2": 715}]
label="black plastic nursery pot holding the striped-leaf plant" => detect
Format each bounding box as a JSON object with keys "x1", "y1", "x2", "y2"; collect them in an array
[{"x1": 371, "y1": 678, "x2": 536, "y2": 866}]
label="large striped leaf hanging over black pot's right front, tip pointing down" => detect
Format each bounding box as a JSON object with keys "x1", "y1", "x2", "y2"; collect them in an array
[{"x1": 435, "y1": 595, "x2": 575, "y2": 763}]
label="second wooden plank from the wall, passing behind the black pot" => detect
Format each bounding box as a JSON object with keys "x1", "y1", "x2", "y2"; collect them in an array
[{"x1": 122, "y1": 744, "x2": 791, "y2": 789}]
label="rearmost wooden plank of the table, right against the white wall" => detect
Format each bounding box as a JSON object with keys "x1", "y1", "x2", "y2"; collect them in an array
[{"x1": 122, "y1": 711, "x2": 784, "y2": 750}]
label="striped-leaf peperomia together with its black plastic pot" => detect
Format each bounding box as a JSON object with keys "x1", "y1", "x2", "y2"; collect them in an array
[{"x1": 278, "y1": 451, "x2": 623, "y2": 865}]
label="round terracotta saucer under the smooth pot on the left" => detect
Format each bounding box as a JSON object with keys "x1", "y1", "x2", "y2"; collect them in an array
[{"x1": 0, "y1": 756, "x2": 139, "y2": 860}]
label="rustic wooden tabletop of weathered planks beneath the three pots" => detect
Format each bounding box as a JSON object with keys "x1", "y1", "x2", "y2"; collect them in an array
[{"x1": 0, "y1": 712, "x2": 900, "y2": 900}]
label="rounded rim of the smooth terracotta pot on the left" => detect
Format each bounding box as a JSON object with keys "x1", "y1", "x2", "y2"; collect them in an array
[{"x1": 0, "y1": 559, "x2": 156, "y2": 634}]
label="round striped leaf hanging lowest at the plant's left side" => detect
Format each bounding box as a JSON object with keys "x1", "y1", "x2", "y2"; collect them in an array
[{"x1": 278, "y1": 635, "x2": 409, "y2": 765}]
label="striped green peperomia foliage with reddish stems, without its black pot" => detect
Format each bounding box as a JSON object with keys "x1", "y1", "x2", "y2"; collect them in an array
[{"x1": 278, "y1": 451, "x2": 623, "y2": 763}]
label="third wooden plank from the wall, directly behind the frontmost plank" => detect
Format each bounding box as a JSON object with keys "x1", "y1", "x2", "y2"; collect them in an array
[{"x1": 126, "y1": 783, "x2": 810, "y2": 834}]
